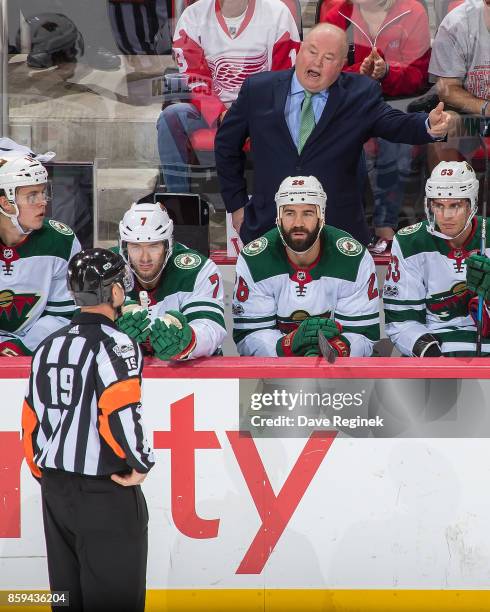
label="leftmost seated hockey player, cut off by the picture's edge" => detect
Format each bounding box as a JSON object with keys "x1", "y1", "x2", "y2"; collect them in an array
[{"x1": 0, "y1": 152, "x2": 80, "y2": 356}]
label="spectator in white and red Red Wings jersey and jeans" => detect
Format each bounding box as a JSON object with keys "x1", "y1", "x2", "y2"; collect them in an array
[{"x1": 157, "y1": 0, "x2": 299, "y2": 193}]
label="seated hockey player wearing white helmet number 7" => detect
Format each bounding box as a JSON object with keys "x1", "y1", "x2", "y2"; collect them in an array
[{"x1": 118, "y1": 203, "x2": 226, "y2": 360}]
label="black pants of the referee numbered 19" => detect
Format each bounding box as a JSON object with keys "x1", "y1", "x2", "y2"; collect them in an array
[{"x1": 41, "y1": 470, "x2": 148, "y2": 612}]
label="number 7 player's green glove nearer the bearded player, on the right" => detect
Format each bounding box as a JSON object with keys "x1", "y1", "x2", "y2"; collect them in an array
[{"x1": 150, "y1": 310, "x2": 196, "y2": 361}]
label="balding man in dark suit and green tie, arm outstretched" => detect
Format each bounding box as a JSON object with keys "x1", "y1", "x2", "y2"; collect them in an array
[{"x1": 216, "y1": 23, "x2": 449, "y2": 244}]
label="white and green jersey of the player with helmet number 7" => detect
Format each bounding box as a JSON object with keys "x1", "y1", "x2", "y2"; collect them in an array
[{"x1": 121, "y1": 242, "x2": 226, "y2": 359}]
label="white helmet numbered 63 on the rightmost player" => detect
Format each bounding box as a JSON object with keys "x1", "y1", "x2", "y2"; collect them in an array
[{"x1": 424, "y1": 161, "x2": 479, "y2": 240}]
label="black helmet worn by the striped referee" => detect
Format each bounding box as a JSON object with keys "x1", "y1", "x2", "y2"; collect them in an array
[{"x1": 67, "y1": 249, "x2": 134, "y2": 306}]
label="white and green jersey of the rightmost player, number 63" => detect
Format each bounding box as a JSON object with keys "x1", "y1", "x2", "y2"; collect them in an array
[{"x1": 383, "y1": 217, "x2": 490, "y2": 357}]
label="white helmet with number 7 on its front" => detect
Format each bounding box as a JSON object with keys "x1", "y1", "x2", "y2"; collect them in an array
[{"x1": 119, "y1": 202, "x2": 174, "y2": 282}]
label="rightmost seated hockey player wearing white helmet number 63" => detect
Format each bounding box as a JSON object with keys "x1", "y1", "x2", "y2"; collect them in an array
[{"x1": 383, "y1": 162, "x2": 490, "y2": 357}]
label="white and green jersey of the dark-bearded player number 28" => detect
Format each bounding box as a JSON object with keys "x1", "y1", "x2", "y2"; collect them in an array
[{"x1": 233, "y1": 226, "x2": 379, "y2": 357}]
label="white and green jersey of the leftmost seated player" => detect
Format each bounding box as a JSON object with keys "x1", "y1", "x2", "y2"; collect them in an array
[{"x1": 0, "y1": 219, "x2": 81, "y2": 355}]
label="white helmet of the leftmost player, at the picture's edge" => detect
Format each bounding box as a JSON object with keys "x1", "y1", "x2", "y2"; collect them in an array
[{"x1": 0, "y1": 151, "x2": 50, "y2": 235}]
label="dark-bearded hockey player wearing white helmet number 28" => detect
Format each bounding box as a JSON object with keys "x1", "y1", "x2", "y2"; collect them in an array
[{"x1": 233, "y1": 176, "x2": 379, "y2": 357}]
